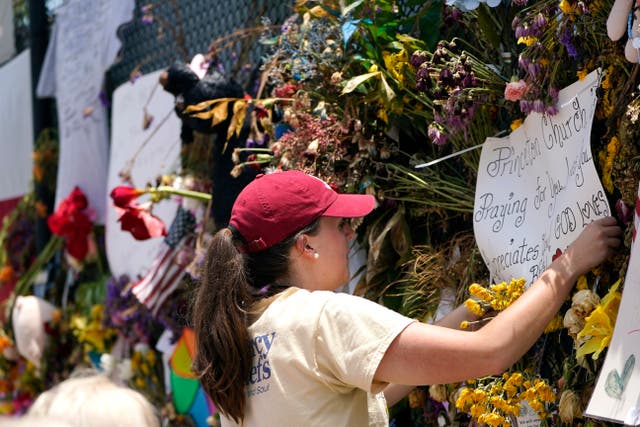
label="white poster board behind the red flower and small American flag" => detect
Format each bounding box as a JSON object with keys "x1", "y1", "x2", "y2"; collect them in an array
[{"x1": 105, "y1": 71, "x2": 181, "y2": 280}]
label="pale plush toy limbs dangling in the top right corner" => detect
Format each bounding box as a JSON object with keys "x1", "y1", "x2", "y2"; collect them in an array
[{"x1": 607, "y1": 0, "x2": 640, "y2": 63}]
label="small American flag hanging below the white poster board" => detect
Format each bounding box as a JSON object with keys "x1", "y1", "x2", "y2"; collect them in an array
[{"x1": 132, "y1": 206, "x2": 196, "y2": 316}]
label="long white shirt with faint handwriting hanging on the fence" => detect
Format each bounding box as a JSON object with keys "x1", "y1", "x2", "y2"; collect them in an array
[{"x1": 37, "y1": 0, "x2": 135, "y2": 224}]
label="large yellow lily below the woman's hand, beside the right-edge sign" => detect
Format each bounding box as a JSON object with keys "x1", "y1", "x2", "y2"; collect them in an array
[{"x1": 576, "y1": 280, "x2": 622, "y2": 360}]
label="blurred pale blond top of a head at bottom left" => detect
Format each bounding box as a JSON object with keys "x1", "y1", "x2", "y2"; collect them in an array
[{"x1": 28, "y1": 373, "x2": 160, "y2": 427}]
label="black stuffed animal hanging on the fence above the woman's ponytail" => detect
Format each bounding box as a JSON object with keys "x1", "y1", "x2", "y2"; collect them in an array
[{"x1": 160, "y1": 61, "x2": 255, "y2": 228}]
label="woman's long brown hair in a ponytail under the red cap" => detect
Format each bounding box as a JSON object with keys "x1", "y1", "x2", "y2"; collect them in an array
[{"x1": 193, "y1": 219, "x2": 319, "y2": 423}]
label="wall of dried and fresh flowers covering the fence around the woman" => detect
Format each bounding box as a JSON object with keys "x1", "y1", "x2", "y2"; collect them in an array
[{"x1": 0, "y1": 0, "x2": 640, "y2": 426}]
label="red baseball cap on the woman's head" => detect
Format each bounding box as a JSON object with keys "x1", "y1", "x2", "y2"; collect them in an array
[{"x1": 229, "y1": 170, "x2": 376, "y2": 252}]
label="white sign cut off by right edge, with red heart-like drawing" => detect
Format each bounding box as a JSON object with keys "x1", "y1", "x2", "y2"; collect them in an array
[{"x1": 586, "y1": 183, "x2": 640, "y2": 425}]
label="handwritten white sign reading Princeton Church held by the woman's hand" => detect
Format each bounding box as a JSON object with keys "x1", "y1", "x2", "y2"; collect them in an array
[{"x1": 473, "y1": 71, "x2": 610, "y2": 283}]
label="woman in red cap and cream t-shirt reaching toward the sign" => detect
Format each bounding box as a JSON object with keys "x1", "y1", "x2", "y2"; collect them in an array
[{"x1": 194, "y1": 171, "x2": 621, "y2": 427}]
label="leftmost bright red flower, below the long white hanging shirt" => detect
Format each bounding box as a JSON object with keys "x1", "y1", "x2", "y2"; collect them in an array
[{"x1": 47, "y1": 187, "x2": 93, "y2": 261}]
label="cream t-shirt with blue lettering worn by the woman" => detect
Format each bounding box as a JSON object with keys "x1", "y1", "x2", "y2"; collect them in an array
[{"x1": 222, "y1": 289, "x2": 414, "y2": 427}]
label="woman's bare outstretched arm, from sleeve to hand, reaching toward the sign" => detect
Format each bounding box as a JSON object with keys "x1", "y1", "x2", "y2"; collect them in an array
[{"x1": 375, "y1": 217, "x2": 622, "y2": 385}]
